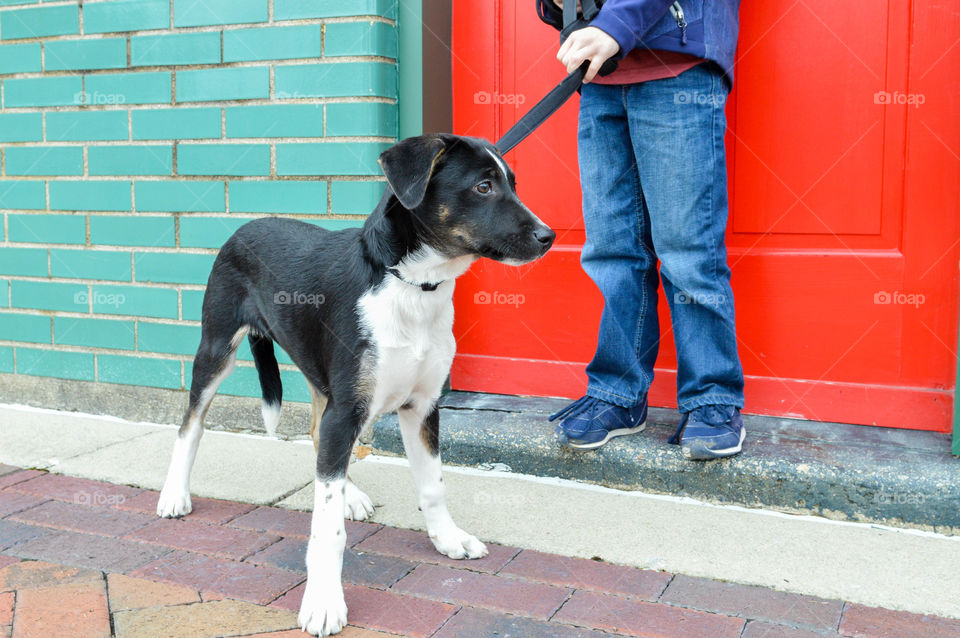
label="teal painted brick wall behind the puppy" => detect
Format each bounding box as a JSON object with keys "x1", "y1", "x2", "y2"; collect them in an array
[{"x1": 0, "y1": 0, "x2": 398, "y2": 401}]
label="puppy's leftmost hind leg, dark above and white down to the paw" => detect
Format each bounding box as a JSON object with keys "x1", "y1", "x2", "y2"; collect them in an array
[{"x1": 157, "y1": 326, "x2": 247, "y2": 518}]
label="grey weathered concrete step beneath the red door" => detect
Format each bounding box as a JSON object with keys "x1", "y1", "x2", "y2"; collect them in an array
[{"x1": 372, "y1": 392, "x2": 960, "y2": 534}]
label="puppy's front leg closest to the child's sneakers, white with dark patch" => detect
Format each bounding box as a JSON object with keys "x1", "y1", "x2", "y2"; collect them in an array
[{"x1": 398, "y1": 403, "x2": 487, "y2": 558}]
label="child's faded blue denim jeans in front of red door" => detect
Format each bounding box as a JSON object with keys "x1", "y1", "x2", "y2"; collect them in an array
[{"x1": 578, "y1": 64, "x2": 743, "y2": 412}]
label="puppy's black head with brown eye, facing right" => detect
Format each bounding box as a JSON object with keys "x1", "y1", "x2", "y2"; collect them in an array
[{"x1": 379, "y1": 134, "x2": 556, "y2": 265}]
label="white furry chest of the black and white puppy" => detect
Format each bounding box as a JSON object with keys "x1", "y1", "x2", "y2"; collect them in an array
[{"x1": 357, "y1": 277, "x2": 456, "y2": 418}]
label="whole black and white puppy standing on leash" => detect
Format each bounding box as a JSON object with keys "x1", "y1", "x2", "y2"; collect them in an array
[{"x1": 157, "y1": 135, "x2": 555, "y2": 635}]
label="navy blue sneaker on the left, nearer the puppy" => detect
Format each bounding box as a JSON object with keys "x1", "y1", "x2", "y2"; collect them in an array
[{"x1": 550, "y1": 397, "x2": 647, "y2": 450}]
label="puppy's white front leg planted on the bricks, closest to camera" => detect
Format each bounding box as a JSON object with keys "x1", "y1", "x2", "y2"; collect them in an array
[{"x1": 298, "y1": 409, "x2": 357, "y2": 636}]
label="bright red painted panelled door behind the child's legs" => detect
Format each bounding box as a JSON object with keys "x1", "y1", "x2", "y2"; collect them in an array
[{"x1": 451, "y1": 0, "x2": 960, "y2": 431}]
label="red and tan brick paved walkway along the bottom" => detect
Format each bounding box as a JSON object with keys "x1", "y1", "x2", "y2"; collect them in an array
[{"x1": 0, "y1": 465, "x2": 960, "y2": 638}]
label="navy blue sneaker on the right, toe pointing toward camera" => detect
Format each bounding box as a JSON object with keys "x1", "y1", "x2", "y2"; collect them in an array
[{"x1": 670, "y1": 405, "x2": 747, "y2": 461}]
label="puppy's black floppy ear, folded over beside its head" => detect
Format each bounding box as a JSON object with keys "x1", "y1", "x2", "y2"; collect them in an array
[{"x1": 377, "y1": 135, "x2": 447, "y2": 210}]
